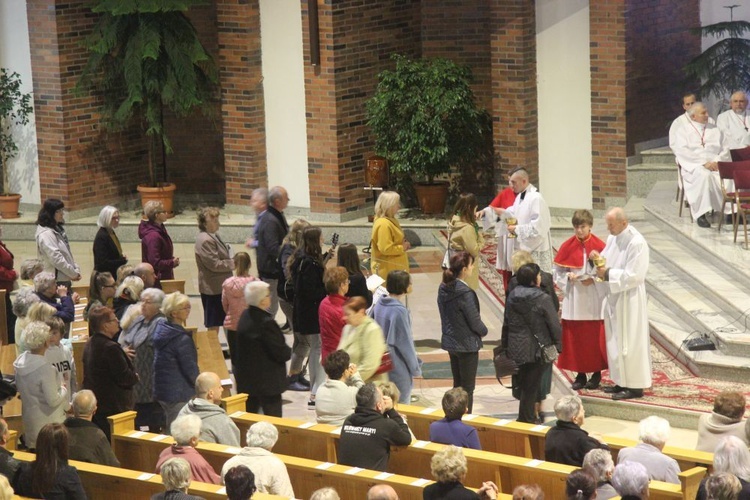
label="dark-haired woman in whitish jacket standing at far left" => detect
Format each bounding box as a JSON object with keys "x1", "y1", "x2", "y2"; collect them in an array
[{"x1": 36, "y1": 198, "x2": 81, "y2": 288}]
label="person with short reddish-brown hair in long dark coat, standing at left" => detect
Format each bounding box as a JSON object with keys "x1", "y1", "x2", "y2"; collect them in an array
[{"x1": 83, "y1": 306, "x2": 138, "y2": 440}]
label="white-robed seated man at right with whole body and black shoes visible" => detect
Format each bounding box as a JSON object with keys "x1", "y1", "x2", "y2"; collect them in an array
[{"x1": 672, "y1": 102, "x2": 732, "y2": 227}]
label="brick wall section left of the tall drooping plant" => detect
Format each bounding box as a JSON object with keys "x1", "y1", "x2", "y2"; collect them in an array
[{"x1": 26, "y1": 0, "x2": 146, "y2": 210}]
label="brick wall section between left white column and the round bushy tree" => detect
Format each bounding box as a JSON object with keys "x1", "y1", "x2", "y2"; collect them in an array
[{"x1": 302, "y1": 0, "x2": 419, "y2": 216}]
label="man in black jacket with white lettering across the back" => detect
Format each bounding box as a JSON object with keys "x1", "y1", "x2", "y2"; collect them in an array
[{"x1": 339, "y1": 383, "x2": 411, "y2": 471}]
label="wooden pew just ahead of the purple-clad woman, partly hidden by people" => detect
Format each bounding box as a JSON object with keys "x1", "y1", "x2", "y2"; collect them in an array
[{"x1": 398, "y1": 404, "x2": 714, "y2": 471}]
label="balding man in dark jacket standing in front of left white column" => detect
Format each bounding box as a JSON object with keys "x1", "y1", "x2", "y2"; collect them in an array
[{"x1": 255, "y1": 186, "x2": 289, "y2": 317}]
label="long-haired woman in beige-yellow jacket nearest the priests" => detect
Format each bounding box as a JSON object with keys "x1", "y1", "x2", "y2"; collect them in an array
[{"x1": 448, "y1": 193, "x2": 481, "y2": 291}]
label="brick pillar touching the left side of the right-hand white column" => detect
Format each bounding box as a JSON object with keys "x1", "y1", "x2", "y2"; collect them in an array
[{"x1": 490, "y1": 0, "x2": 539, "y2": 183}]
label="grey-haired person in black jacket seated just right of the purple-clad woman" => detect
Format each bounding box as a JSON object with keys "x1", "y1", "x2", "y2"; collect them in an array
[{"x1": 544, "y1": 396, "x2": 609, "y2": 467}]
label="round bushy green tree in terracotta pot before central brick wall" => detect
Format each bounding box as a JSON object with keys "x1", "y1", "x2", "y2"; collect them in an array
[{"x1": 367, "y1": 54, "x2": 490, "y2": 214}]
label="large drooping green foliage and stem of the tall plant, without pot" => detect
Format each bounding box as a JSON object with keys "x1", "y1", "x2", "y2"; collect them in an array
[{"x1": 78, "y1": 0, "x2": 218, "y2": 186}]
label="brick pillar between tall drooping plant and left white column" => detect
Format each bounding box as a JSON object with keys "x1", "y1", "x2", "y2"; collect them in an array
[{"x1": 216, "y1": 0, "x2": 268, "y2": 206}]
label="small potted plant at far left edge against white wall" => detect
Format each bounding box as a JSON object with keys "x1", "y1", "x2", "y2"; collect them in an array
[{"x1": 0, "y1": 68, "x2": 34, "y2": 219}]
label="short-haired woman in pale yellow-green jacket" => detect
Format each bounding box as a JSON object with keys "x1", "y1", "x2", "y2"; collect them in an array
[{"x1": 339, "y1": 297, "x2": 390, "y2": 383}]
